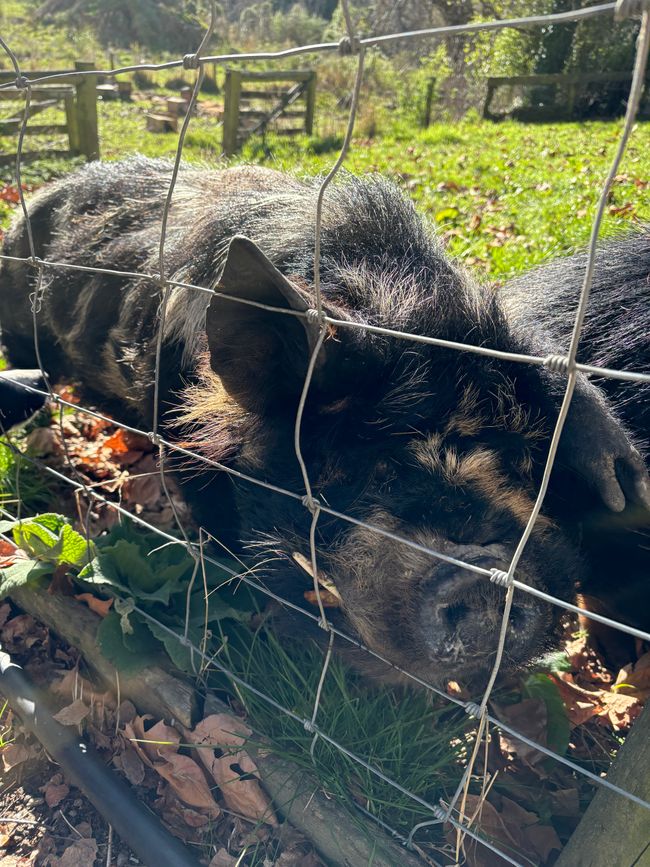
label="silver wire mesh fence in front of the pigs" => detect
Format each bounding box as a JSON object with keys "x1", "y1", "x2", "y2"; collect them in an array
[{"x1": 0, "y1": 0, "x2": 650, "y2": 865}]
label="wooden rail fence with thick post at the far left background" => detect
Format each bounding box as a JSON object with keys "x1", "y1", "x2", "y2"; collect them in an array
[{"x1": 0, "y1": 61, "x2": 99, "y2": 162}]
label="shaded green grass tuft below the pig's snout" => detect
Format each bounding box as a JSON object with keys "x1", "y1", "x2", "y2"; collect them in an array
[{"x1": 213, "y1": 616, "x2": 471, "y2": 831}]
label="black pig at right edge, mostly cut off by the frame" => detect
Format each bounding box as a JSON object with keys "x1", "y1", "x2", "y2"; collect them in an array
[{"x1": 502, "y1": 234, "x2": 650, "y2": 664}]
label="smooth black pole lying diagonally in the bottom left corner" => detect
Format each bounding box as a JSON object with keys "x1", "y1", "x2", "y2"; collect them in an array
[{"x1": 0, "y1": 650, "x2": 199, "y2": 867}]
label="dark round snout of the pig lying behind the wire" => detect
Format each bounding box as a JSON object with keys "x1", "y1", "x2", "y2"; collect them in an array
[{"x1": 420, "y1": 550, "x2": 548, "y2": 666}]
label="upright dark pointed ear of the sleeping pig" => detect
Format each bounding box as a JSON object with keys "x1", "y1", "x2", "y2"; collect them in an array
[{"x1": 206, "y1": 236, "x2": 318, "y2": 411}]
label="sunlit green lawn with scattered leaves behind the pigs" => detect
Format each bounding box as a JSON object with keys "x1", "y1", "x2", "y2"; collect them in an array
[{"x1": 0, "y1": 107, "x2": 650, "y2": 279}]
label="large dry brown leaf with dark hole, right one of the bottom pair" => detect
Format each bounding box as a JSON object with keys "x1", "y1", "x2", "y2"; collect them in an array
[{"x1": 187, "y1": 714, "x2": 278, "y2": 825}]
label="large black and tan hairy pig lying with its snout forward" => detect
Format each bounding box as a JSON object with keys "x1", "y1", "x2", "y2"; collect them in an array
[{"x1": 0, "y1": 158, "x2": 647, "y2": 681}]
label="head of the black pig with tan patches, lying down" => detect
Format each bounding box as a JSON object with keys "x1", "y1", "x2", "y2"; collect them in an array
[{"x1": 178, "y1": 239, "x2": 636, "y2": 682}]
